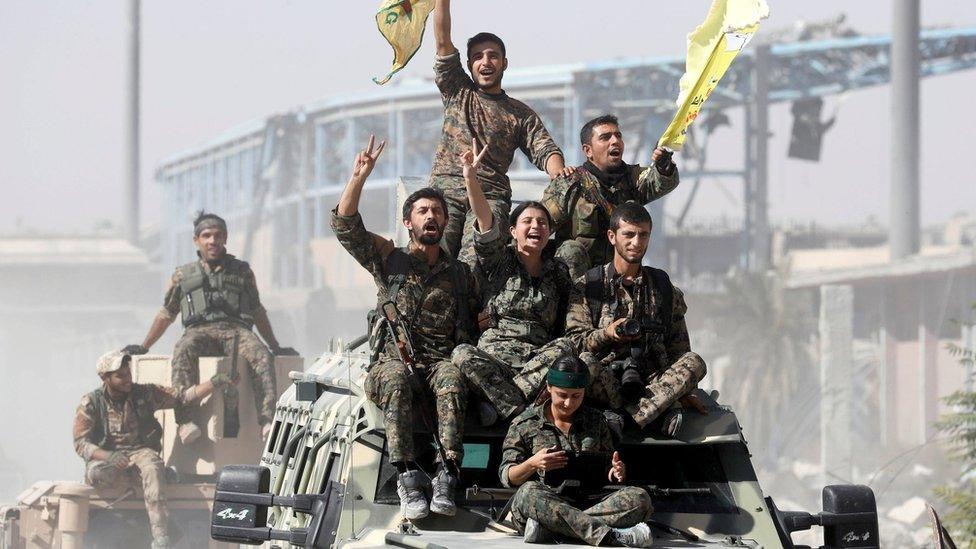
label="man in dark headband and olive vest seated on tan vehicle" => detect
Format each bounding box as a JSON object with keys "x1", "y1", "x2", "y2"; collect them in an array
[{"x1": 123, "y1": 211, "x2": 298, "y2": 444}]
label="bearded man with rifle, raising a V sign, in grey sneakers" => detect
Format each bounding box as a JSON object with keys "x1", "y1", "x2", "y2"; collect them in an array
[{"x1": 332, "y1": 136, "x2": 477, "y2": 519}]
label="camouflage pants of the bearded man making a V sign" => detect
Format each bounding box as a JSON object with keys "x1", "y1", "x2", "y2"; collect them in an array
[{"x1": 366, "y1": 360, "x2": 467, "y2": 463}]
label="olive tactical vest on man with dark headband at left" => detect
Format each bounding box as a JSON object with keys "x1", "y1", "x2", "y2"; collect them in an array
[{"x1": 179, "y1": 256, "x2": 257, "y2": 328}]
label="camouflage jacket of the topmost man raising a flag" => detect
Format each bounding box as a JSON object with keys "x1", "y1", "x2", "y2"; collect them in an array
[{"x1": 430, "y1": 52, "x2": 562, "y2": 201}]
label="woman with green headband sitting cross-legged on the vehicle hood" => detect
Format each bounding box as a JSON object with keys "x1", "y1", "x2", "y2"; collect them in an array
[{"x1": 499, "y1": 356, "x2": 652, "y2": 547}]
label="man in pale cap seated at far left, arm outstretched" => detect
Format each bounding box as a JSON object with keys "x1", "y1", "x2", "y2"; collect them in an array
[{"x1": 73, "y1": 351, "x2": 230, "y2": 549}]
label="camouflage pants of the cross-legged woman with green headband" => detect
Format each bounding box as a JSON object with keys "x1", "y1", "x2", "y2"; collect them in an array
[{"x1": 512, "y1": 480, "x2": 653, "y2": 545}]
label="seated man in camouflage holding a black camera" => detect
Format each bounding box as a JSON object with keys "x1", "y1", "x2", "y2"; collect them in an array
[{"x1": 567, "y1": 202, "x2": 706, "y2": 436}]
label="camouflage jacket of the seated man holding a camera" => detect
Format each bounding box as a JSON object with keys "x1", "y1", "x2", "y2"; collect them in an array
[{"x1": 566, "y1": 263, "x2": 691, "y2": 374}]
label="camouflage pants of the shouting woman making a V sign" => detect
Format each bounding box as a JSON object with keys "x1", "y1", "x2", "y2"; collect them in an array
[{"x1": 451, "y1": 338, "x2": 576, "y2": 419}]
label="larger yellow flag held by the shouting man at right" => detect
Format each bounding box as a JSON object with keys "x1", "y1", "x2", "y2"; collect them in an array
[{"x1": 658, "y1": 0, "x2": 769, "y2": 151}]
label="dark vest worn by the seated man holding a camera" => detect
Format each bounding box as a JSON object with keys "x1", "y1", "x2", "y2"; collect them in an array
[{"x1": 583, "y1": 265, "x2": 674, "y2": 368}]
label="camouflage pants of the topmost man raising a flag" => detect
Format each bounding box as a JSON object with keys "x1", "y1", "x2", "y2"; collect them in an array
[{"x1": 430, "y1": 176, "x2": 512, "y2": 265}]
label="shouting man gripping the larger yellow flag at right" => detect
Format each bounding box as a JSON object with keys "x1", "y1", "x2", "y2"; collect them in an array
[{"x1": 542, "y1": 114, "x2": 678, "y2": 280}]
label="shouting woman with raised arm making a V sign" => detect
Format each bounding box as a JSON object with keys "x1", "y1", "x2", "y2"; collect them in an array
[{"x1": 451, "y1": 141, "x2": 578, "y2": 427}]
